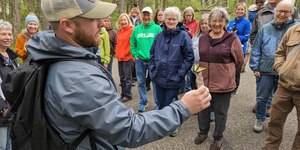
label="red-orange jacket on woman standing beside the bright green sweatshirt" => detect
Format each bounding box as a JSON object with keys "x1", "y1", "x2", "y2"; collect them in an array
[{"x1": 116, "y1": 26, "x2": 133, "y2": 61}]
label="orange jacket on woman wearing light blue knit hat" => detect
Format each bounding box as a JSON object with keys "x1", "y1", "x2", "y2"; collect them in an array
[{"x1": 15, "y1": 33, "x2": 30, "y2": 63}]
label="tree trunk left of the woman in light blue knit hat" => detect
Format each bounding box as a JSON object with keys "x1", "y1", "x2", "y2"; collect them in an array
[{"x1": 10, "y1": 0, "x2": 21, "y2": 37}]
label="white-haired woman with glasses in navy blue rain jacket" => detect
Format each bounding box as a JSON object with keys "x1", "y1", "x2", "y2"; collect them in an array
[{"x1": 149, "y1": 7, "x2": 194, "y2": 112}]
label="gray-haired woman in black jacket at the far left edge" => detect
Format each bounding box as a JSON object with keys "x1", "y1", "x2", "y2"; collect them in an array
[{"x1": 0, "y1": 20, "x2": 18, "y2": 150}]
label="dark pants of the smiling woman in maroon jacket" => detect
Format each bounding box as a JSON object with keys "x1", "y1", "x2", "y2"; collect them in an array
[{"x1": 198, "y1": 92, "x2": 231, "y2": 140}]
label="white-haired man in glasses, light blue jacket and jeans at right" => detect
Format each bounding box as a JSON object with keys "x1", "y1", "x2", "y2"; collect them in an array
[{"x1": 249, "y1": 1, "x2": 296, "y2": 133}]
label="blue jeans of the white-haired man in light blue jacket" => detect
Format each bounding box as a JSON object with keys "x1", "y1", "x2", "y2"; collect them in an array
[{"x1": 256, "y1": 75, "x2": 278, "y2": 121}]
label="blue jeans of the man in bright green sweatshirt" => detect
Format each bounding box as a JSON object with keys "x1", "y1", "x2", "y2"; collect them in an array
[{"x1": 135, "y1": 59, "x2": 157, "y2": 105}]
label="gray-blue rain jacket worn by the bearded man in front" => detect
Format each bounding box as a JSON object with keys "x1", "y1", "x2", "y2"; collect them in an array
[{"x1": 27, "y1": 31, "x2": 190, "y2": 150}]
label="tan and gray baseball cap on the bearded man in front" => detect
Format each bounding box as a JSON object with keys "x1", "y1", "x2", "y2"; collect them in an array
[{"x1": 41, "y1": 0, "x2": 117, "y2": 21}]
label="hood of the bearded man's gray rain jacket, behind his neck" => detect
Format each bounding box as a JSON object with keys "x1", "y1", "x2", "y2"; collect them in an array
[{"x1": 26, "y1": 30, "x2": 98, "y2": 61}]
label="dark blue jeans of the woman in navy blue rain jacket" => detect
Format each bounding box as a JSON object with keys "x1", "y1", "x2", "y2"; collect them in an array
[{"x1": 154, "y1": 84, "x2": 179, "y2": 109}]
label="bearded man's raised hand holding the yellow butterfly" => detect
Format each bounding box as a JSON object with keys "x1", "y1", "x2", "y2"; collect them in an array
[{"x1": 181, "y1": 86, "x2": 211, "y2": 115}]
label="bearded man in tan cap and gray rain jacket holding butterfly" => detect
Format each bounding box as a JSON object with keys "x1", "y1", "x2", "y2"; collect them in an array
[{"x1": 27, "y1": 0, "x2": 211, "y2": 150}]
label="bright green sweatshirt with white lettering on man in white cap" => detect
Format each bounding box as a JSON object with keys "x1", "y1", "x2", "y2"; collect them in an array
[{"x1": 130, "y1": 21, "x2": 162, "y2": 61}]
